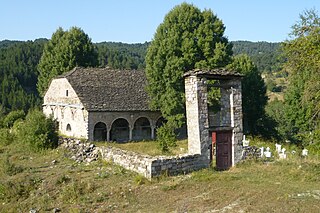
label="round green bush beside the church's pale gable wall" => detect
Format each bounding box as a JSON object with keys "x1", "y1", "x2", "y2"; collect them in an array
[{"x1": 17, "y1": 110, "x2": 58, "y2": 151}]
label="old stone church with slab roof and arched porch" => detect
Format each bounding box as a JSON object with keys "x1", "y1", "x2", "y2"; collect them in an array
[{"x1": 43, "y1": 67, "x2": 164, "y2": 142}]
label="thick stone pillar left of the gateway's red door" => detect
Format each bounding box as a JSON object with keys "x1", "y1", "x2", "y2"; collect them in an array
[{"x1": 185, "y1": 75, "x2": 210, "y2": 157}]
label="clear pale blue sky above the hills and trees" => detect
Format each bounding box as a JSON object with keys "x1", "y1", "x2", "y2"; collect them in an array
[{"x1": 0, "y1": 0, "x2": 320, "y2": 43}]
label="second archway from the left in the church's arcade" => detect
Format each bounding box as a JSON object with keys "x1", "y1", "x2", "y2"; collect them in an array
[{"x1": 110, "y1": 118, "x2": 130, "y2": 142}]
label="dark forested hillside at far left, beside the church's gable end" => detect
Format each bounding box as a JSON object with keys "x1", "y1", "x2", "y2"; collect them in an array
[{"x1": 0, "y1": 39, "x2": 46, "y2": 113}]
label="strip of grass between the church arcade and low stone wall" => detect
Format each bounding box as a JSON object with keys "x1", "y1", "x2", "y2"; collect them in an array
[{"x1": 95, "y1": 140, "x2": 188, "y2": 156}]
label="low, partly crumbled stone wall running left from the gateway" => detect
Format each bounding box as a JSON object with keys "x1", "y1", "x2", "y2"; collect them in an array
[{"x1": 59, "y1": 137, "x2": 209, "y2": 179}]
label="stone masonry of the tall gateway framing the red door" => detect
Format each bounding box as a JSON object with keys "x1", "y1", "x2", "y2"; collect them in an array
[{"x1": 185, "y1": 75, "x2": 243, "y2": 169}]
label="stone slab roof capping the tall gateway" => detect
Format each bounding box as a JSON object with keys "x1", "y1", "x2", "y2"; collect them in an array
[{"x1": 183, "y1": 68, "x2": 243, "y2": 79}]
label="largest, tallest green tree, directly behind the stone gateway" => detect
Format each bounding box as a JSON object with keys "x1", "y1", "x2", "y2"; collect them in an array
[{"x1": 146, "y1": 3, "x2": 232, "y2": 138}]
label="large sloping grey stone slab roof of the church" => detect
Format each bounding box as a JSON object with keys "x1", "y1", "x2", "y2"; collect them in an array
[{"x1": 58, "y1": 67, "x2": 150, "y2": 111}]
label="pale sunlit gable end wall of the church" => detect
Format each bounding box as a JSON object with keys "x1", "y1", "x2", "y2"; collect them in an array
[{"x1": 43, "y1": 78, "x2": 88, "y2": 138}]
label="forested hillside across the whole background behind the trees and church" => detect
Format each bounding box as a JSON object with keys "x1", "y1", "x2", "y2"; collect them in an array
[{"x1": 0, "y1": 39, "x2": 280, "y2": 113}]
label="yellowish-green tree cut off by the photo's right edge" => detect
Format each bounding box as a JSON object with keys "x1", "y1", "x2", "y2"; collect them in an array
[{"x1": 283, "y1": 9, "x2": 320, "y2": 142}]
